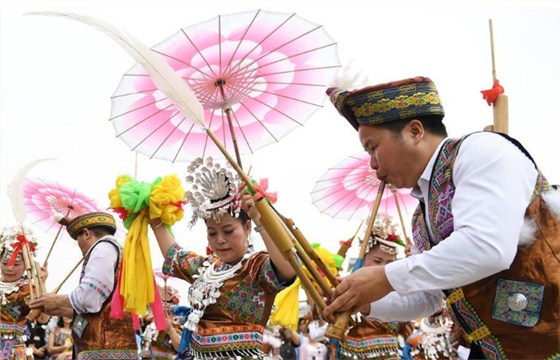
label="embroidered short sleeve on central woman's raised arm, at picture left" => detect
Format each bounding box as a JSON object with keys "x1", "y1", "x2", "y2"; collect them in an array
[{"x1": 162, "y1": 243, "x2": 206, "y2": 283}]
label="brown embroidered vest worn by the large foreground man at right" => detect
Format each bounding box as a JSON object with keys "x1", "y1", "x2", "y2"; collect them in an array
[{"x1": 412, "y1": 136, "x2": 560, "y2": 359}]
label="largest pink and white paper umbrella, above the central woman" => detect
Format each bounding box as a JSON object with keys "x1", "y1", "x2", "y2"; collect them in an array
[{"x1": 111, "y1": 10, "x2": 340, "y2": 162}]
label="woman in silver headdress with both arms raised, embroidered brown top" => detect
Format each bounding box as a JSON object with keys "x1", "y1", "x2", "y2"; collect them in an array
[{"x1": 150, "y1": 158, "x2": 295, "y2": 359}]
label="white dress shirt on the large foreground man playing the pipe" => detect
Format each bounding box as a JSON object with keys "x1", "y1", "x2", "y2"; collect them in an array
[{"x1": 369, "y1": 132, "x2": 537, "y2": 321}]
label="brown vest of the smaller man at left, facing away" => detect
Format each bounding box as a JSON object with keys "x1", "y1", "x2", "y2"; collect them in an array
[{"x1": 72, "y1": 238, "x2": 137, "y2": 359}]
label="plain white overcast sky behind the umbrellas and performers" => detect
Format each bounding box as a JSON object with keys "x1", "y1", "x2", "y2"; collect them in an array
[{"x1": 0, "y1": 0, "x2": 560, "y2": 288}]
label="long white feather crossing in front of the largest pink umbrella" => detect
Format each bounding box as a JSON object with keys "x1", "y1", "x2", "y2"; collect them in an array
[{"x1": 27, "y1": 11, "x2": 206, "y2": 129}]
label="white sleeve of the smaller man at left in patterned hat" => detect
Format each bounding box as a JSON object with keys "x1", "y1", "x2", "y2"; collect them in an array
[{"x1": 70, "y1": 242, "x2": 118, "y2": 314}]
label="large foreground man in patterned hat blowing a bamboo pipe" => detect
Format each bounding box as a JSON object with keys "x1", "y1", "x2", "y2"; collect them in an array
[{"x1": 324, "y1": 77, "x2": 560, "y2": 359}]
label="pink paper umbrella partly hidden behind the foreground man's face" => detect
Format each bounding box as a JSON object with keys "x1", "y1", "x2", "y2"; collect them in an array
[{"x1": 311, "y1": 152, "x2": 418, "y2": 220}]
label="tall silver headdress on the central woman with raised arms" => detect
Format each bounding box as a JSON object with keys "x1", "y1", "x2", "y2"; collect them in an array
[{"x1": 186, "y1": 157, "x2": 241, "y2": 226}]
